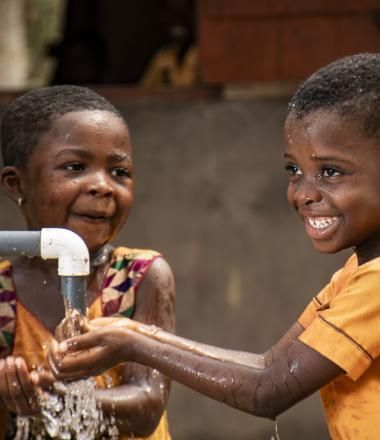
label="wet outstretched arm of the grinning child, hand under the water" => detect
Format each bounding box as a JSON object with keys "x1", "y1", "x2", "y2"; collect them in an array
[{"x1": 50, "y1": 320, "x2": 344, "y2": 419}]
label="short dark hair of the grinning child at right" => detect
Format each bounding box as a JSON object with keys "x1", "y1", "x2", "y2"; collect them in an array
[{"x1": 288, "y1": 53, "x2": 380, "y2": 136}]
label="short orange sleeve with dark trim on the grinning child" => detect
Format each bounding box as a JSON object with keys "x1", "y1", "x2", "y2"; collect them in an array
[{"x1": 299, "y1": 259, "x2": 380, "y2": 380}]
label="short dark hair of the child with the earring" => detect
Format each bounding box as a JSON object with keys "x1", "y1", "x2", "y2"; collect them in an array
[{"x1": 1, "y1": 85, "x2": 125, "y2": 166}]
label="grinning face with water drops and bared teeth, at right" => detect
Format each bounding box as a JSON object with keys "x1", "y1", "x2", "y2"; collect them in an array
[{"x1": 285, "y1": 110, "x2": 380, "y2": 262}]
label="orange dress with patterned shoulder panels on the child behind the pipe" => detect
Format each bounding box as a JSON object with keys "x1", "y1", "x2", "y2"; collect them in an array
[{"x1": 0, "y1": 247, "x2": 171, "y2": 440}]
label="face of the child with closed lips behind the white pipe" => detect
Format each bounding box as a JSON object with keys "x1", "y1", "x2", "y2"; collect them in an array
[{"x1": 21, "y1": 110, "x2": 133, "y2": 253}]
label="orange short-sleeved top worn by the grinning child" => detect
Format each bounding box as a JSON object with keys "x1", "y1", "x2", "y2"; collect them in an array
[{"x1": 298, "y1": 255, "x2": 380, "y2": 440}]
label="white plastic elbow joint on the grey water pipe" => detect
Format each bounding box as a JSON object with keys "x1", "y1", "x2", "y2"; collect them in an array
[{"x1": 40, "y1": 228, "x2": 90, "y2": 276}]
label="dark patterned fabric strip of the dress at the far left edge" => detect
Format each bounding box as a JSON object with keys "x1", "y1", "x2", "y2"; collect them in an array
[{"x1": 0, "y1": 261, "x2": 16, "y2": 356}]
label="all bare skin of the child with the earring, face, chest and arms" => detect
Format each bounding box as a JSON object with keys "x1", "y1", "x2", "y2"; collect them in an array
[{"x1": 0, "y1": 111, "x2": 174, "y2": 436}]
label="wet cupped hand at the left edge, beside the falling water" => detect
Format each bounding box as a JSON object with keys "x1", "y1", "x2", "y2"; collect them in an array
[{"x1": 0, "y1": 356, "x2": 41, "y2": 415}]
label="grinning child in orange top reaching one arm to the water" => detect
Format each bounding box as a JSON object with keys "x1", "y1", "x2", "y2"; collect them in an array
[{"x1": 50, "y1": 54, "x2": 380, "y2": 440}]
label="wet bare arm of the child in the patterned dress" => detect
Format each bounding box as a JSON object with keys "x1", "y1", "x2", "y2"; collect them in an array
[{"x1": 96, "y1": 258, "x2": 175, "y2": 437}]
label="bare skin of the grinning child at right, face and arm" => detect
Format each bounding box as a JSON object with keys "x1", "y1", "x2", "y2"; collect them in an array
[{"x1": 50, "y1": 111, "x2": 380, "y2": 418}]
